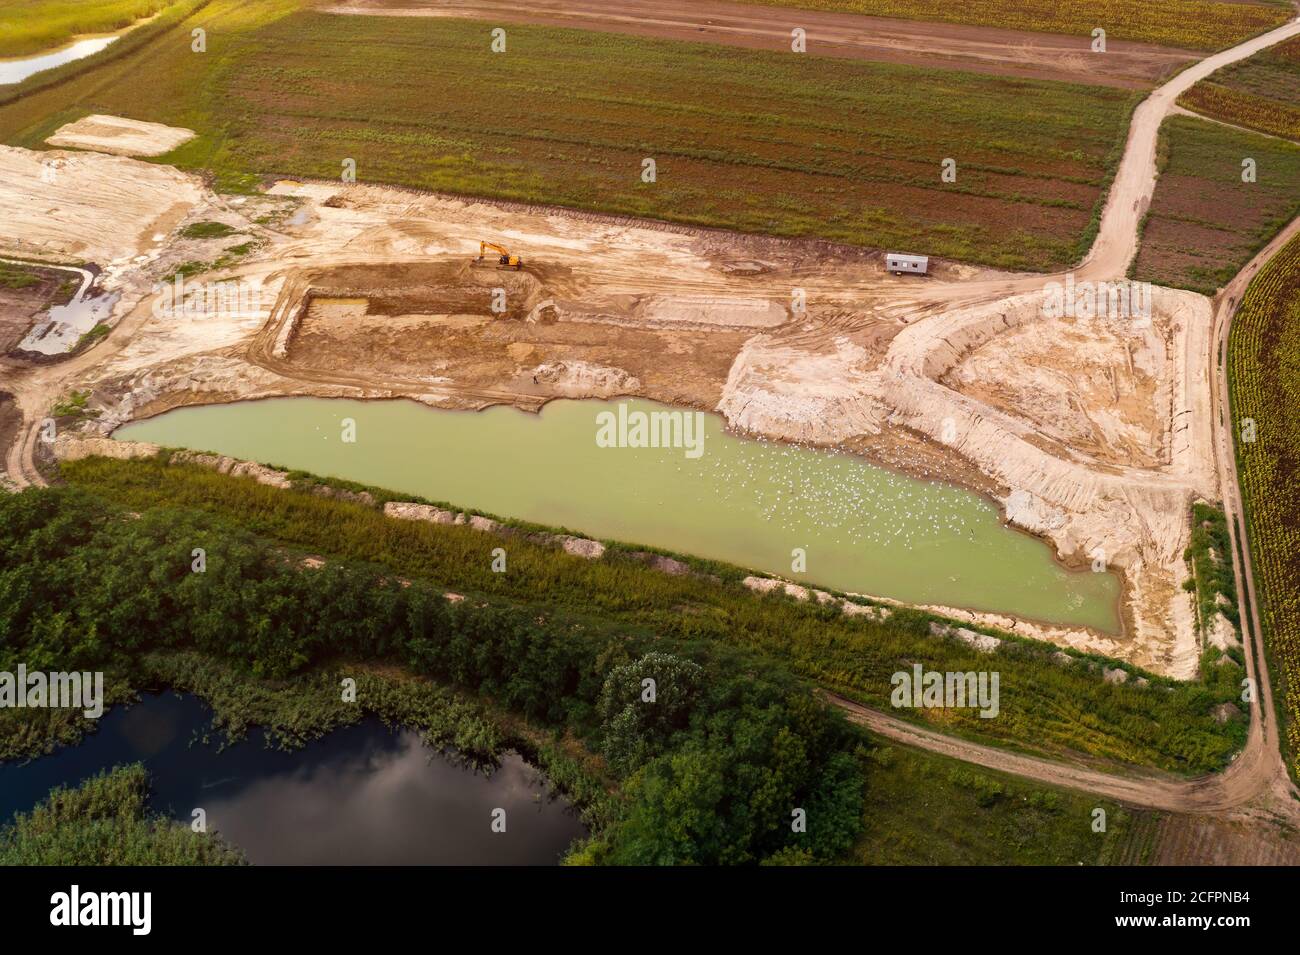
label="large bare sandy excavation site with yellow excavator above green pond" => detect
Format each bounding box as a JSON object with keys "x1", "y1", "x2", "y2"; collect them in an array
[{"x1": 0, "y1": 151, "x2": 1217, "y2": 676}]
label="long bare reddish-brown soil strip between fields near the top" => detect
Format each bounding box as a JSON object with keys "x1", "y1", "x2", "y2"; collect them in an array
[{"x1": 322, "y1": 0, "x2": 1200, "y2": 90}]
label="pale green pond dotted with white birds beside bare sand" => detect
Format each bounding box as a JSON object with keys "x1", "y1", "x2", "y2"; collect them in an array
[{"x1": 114, "y1": 398, "x2": 1119, "y2": 633}]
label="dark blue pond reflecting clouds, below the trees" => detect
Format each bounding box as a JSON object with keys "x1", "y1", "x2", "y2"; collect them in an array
[{"x1": 0, "y1": 693, "x2": 584, "y2": 865}]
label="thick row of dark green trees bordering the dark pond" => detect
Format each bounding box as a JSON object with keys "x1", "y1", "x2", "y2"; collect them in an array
[{"x1": 0, "y1": 487, "x2": 863, "y2": 864}]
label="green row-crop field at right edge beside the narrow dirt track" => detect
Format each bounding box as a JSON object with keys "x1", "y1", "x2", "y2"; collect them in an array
[{"x1": 1229, "y1": 239, "x2": 1300, "y2": 774}]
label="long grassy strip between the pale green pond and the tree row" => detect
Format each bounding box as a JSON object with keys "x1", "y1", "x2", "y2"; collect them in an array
[{"x1": 35, "y1": 452, "x2": 1245, "y2": 774}]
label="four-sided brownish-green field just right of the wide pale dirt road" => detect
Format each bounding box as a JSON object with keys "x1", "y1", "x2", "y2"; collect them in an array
[{"x1": 1134, "y1": 116, "x2": 1300, "y2": 295}]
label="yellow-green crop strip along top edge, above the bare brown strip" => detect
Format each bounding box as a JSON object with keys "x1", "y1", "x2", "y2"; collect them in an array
[{"x1": 749, "y1": 0, "x2": 1291, "y2": 49}]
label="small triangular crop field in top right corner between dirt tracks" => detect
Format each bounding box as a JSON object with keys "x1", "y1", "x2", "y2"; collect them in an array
[{"x1": 1178, "y1": 36, "x2": 1300, "y2": 140}]
